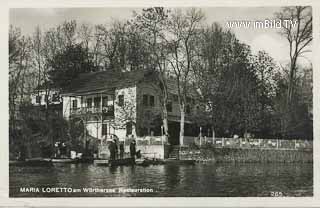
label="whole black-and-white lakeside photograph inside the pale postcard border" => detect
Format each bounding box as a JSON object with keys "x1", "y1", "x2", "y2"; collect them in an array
[{"x1": 7, "y1": 5, "x2": 312, "y2": 198}]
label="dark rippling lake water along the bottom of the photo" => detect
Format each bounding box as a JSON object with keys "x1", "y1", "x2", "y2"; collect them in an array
[{"x1": 9, "y1": 163, "x2": 313, "y2": 197}]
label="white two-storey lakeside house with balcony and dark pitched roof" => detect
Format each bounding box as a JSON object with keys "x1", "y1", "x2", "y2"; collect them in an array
[{"x1": 61, "y1": 71, "x2": 199, "y2": 145}]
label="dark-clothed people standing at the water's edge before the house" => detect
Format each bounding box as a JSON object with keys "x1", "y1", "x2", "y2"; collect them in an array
[{"x1": 109, "y1": 139, "x2": 136, "y2": 160}]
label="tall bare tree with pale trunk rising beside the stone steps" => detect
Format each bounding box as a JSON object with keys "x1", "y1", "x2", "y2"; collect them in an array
[{"x1": 168, "y1": 8, "x2": 204, "y2": 145}]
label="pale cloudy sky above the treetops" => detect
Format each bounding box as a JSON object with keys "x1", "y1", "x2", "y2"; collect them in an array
[{"x1": 9, "y1": 7, "x2": 311, "y2": 65}]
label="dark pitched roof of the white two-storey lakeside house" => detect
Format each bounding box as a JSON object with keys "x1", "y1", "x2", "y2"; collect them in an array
[{"x1": 62, "y1": 70, "x2": 154, "y2": 95}]
